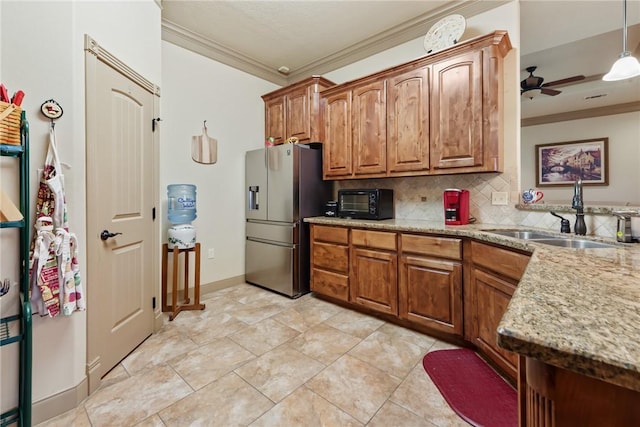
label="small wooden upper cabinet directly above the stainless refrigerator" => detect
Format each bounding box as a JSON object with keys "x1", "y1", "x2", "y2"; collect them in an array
[{"x1": 262, "y1": 76, "x2": 334, "y2": 144}]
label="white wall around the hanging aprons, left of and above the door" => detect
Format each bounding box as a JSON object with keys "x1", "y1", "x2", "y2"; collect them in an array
[{"x1": 0, "y1": 0, "x2": 161, "y2": 414}]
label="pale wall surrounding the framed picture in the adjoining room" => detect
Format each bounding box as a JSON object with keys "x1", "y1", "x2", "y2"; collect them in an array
[{"x1": 521, "y1": 111, "x2": 640, "y2": 206}]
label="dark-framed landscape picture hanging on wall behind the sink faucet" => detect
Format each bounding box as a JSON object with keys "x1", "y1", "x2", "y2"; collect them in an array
[{"x1": 536, "y1": 138, "x2": 609, "y2": 187}]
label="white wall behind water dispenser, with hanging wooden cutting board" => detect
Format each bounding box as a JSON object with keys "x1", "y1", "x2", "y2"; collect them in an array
[{"x1": 160, "y1": 42, "x2": 278, "y2": 284}]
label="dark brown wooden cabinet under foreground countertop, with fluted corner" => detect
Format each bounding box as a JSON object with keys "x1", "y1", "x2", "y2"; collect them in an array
[{"x1": 519, "y1": 358, "x2": 640, "y2": 427}]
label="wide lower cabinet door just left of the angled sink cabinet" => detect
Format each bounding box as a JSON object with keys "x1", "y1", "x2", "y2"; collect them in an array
[{"x1": 398, "y1": 255, "x2": 463, "y2": 336}]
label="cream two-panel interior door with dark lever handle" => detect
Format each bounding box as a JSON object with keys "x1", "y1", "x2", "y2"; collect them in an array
[{"x1": 86, "y1": 38, "x2": 159, "y2": 392}]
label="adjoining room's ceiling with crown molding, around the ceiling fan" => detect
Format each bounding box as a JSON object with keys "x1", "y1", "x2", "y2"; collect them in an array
[{"x1": 520, "y1": 0, "x2": 640, "y2": 125}]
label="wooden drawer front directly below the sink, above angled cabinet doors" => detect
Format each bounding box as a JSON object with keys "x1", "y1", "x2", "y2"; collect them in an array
[{"x1": 471, "y1": 241, "x2": 529, "y2": 280}]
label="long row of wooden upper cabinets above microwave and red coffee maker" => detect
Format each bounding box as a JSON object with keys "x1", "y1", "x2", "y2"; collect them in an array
[{"x1": 320, "y1": 31, "x2": 511, "y2": 179}]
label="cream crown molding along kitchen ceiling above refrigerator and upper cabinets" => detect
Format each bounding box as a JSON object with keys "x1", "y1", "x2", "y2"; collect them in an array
[{"x1": 162, "y1": 0, "x2": 512, "y2": 86}]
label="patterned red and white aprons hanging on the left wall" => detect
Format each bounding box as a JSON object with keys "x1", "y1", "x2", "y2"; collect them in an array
[{"x1": 31, "y1": 126, "x2": 85, "y2": 317}]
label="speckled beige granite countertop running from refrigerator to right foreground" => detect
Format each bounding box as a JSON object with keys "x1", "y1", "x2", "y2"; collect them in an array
[{"x1": 305, "y1": 217, "x2": 640, "y2": 391}]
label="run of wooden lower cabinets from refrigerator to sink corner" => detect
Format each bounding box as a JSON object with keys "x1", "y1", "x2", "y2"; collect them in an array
[{"x1": 311, "y1": 224, "x2": 529, "y2": 366}]
